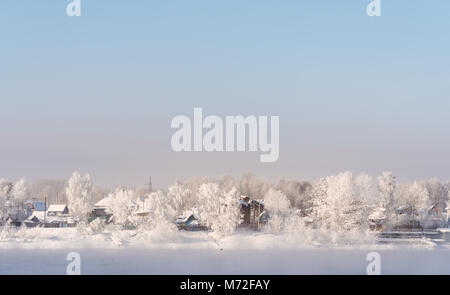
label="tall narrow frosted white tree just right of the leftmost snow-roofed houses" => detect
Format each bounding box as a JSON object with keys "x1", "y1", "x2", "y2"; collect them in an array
[{"x1": 66, "y1": 172, "x2": 93, "y2": 222}]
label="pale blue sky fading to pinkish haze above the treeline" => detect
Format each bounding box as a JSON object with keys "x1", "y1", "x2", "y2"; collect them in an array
[{"x1": 0, "y1": 0, "x2": 450, "y2": 187}]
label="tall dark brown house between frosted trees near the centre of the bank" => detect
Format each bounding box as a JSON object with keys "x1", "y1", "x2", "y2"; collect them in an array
[{"x1": 238, "y1": 197, "x2": 267, "y2": 229}]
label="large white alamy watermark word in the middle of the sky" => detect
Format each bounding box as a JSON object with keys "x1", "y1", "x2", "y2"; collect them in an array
[{"x1": 171, "y1": 108, "x2": 280, "y2": 162}]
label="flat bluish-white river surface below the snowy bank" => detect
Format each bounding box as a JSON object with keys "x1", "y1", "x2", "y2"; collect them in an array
[{"x1": 0, "y1": 248, "x2": 450, "y2": 275}]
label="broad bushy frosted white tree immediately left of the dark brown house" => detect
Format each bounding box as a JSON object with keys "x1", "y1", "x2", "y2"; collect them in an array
[{"x1": 198, "y1": 183, "x2": 241, "y2": 234}]
